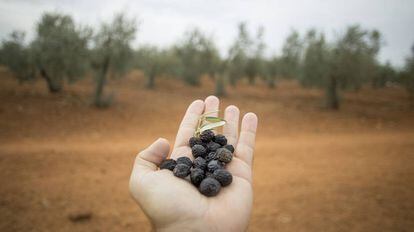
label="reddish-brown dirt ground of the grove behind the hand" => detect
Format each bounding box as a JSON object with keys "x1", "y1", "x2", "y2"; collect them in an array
[{"x1": 0, "y1": 70, "x2": 414, "y2": 231}]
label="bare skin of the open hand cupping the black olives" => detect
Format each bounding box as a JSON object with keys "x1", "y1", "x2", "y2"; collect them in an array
[{"x1": 130, "y1": 96, "x2": 257, "y2": 231}]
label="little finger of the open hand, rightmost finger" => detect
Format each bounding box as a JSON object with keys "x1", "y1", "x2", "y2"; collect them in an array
[{"x1": 236, "y1": 113, "x2": 257, "y2": 167}]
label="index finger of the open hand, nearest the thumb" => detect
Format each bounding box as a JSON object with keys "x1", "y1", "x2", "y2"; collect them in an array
[{"x1": 174, "y1": 100, "x2": 204, "y2": 148}]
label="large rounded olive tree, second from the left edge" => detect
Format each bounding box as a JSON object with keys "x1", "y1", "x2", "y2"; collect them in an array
[{"x1": 32, "y1": 13, "x2": 91, "y2": 92}]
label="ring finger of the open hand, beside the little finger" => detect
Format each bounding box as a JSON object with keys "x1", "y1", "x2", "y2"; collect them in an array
[{"x1": 223, "y1": 105, "x2": 240, "y2": 146}]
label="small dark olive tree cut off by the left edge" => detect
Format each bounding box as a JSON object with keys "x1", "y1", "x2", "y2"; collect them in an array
[{"x1": 0, "y1": 31, "x2": 35, "y2": 82}]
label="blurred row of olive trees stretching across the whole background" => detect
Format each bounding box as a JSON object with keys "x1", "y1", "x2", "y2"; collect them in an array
[{"x1": 0, "y1": 10, "x2": 402, "y2": 108}]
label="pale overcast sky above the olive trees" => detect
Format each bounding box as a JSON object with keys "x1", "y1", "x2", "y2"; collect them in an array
[{"x1": 0, "y1": 0, "x2": 414, "y2": 66}]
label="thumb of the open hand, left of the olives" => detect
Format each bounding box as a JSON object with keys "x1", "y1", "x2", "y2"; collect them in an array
[{"x1": 131, "y1": 138, "x2": 170, "y2": 181}]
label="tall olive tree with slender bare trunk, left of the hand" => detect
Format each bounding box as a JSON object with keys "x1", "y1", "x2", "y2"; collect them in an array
[{"x1": 92, "y1": 14, "x2": 137, "y2": 107}]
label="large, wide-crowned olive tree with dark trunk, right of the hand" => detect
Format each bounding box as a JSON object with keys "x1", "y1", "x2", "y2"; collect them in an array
[{"x1": 300, "y1": 26, "x2": 380, "y2": 109}]
